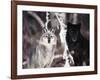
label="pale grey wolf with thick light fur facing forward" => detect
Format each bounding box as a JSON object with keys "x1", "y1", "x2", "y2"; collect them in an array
[{"x1": 31, "y1": 31, "x2": 57, "y2": 68}]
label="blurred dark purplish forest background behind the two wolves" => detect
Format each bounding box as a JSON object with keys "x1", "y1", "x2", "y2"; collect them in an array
[{"x1": 22, "y1": 11, "x2": 89, "y2": 68}]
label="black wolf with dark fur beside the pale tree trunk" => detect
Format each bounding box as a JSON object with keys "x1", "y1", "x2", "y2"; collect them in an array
[{"x1": 66, "y1": 23, "x2": 89, "y2": 66}]
